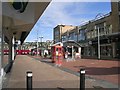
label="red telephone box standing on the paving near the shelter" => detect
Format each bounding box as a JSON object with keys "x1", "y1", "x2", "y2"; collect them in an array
[{"x1": 51, "y1": 45, "x2": 63, "y2": 66}]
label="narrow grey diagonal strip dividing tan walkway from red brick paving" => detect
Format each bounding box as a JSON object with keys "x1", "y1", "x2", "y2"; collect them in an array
[{"x1": 28, "y1": 57, "x2": 120, "y2": 90}]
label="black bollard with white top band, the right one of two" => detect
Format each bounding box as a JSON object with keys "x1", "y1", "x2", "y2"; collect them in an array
[{"x1": 80, "y1": 68, "x2": 85, "y2": 90}]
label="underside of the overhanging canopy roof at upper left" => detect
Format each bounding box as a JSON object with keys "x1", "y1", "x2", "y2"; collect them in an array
[{"x1": 2, "y1": 2, "x2": 50, "y2": 44}]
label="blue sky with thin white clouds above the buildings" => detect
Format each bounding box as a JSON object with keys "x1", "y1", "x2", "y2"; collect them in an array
[{"x1": 25, "y1": 0, "x2": 111, "y2": 42}]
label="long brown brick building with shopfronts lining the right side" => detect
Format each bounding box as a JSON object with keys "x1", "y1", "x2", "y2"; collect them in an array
[{"x1": 54, "y1": 1, "x2": 120, "y2": 59}]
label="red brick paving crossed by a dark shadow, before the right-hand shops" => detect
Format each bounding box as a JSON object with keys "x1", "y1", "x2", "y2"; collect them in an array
[{"x1": 29, "y1": 56, "x2": 120, "y2": 86}]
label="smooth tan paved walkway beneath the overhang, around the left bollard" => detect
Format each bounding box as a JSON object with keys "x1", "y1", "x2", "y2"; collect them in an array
[{"x1": 4, "y1": 55, "x2": 119, "y2": 90}]
